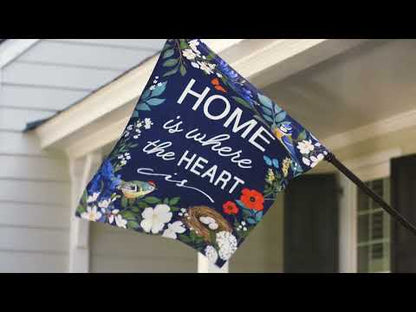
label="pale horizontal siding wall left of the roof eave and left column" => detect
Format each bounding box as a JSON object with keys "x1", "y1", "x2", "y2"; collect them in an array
[{"x1": 0, "y1": 39, "x2": 163, "y2": 272}]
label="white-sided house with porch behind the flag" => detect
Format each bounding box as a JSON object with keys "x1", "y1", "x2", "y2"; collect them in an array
[{"x1": 0, "y1": 39, "x2": 416, "y2": 272}]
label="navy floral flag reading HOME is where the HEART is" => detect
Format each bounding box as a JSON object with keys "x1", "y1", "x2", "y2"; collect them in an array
[{"x1": 76, "y1": 39, "x2": 328, "y2": 267}]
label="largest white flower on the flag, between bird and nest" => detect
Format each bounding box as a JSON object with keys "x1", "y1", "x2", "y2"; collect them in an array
[{"x1": 140, "y1": 204, "x2": 172, "y2": 234}]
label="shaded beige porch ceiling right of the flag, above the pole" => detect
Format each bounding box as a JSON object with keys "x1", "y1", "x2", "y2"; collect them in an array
[{"x1": 265, "y1": 40, "x2": 416, "y2": 144}]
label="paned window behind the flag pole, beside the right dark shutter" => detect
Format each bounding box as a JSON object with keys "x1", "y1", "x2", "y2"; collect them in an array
[{"x1": 357, "y1": 178, "x2": 390, "y2": 272}]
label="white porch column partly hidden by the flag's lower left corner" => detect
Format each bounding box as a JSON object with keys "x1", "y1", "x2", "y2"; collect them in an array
[{"x1": 69, "y1": 151, "x2": 102, "y2": 273}]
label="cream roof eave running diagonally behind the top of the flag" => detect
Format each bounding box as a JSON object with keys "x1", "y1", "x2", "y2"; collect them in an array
[{"x1": 31, "y1": 39, "x2": 364, "y2": 158}]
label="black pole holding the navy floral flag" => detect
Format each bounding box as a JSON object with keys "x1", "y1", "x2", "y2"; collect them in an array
[{"x1": 325, "y1": 153, "x2": 416, "y2": 235}]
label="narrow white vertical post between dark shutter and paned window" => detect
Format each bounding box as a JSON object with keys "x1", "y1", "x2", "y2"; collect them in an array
[{"x1": 338, "y1": 173, "x2": 357, "y2": 273}]
